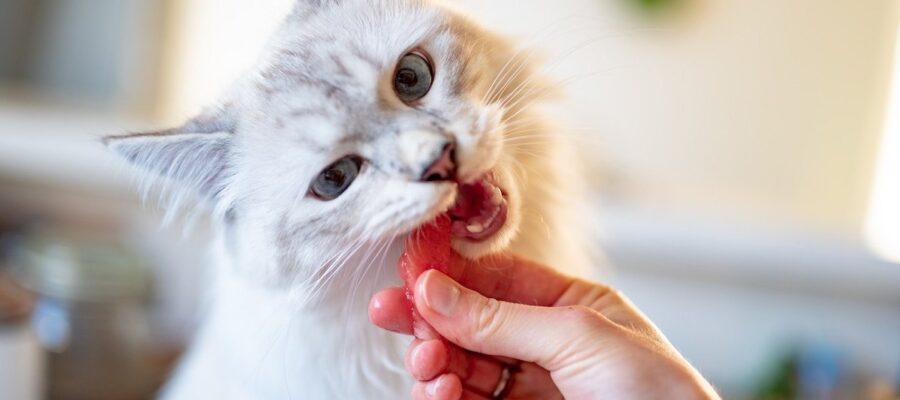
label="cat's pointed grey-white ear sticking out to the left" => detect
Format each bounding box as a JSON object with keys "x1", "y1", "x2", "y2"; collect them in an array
[{"x1": 103, "y1": 107, "x2": 234, "y2": 199}]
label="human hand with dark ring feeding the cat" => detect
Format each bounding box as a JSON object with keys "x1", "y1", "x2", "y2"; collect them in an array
[{"x1": 369, "y1": 255, "x2": 718, "y2": 400}]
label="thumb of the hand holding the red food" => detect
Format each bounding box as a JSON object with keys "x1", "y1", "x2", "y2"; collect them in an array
[{"x1": 415, "y1": 270, "x2": 612, "y2": 371}]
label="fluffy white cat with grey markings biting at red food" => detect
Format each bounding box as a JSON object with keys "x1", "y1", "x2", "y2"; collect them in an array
[{"x1": 104, "y1": 0, "x2": 588, "y2": 400}]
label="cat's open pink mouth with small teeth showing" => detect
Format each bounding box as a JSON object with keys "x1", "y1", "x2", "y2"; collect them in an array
[{"x1": 448, "y1": 179, "x2": 509, "y2": 242}]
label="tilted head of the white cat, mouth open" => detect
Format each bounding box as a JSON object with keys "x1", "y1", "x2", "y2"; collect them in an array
[{"x1": 107, "y1": 0, "x2": 542, "y2": 286}]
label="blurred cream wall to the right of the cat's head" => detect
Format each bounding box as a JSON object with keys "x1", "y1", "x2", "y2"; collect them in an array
[{"x1": 459, "y1": 0, "x2": 897, "y2": 236}]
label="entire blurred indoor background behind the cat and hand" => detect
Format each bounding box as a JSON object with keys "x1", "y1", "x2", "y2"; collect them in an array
[{"x1": 0, "y1": 0, "x2": 900, "y2": 400}]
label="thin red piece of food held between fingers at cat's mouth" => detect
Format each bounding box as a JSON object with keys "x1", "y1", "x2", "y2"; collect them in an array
[{"x1": 397, "y1": 214, "x2": 454, "y2": 340}]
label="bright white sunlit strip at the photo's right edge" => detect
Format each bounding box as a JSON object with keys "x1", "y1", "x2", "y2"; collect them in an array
[{"x1": 866, "y1": 23, "x2": 900, "y2": 262}]
